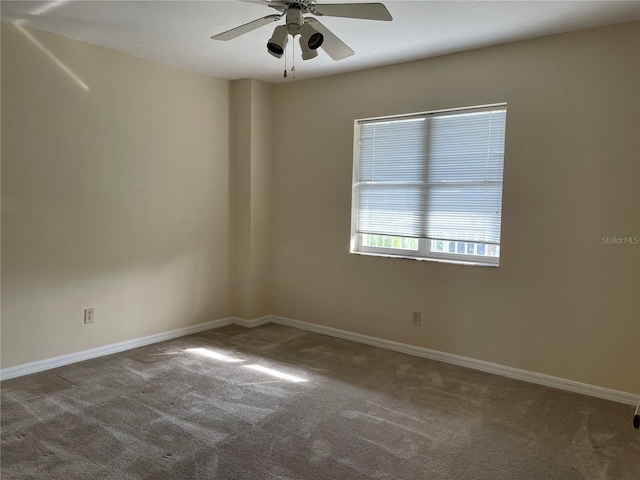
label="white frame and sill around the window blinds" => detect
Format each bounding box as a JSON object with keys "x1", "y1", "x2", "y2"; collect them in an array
[{"x1": 350, "y1": 103, "x2": 507, "y2": 267}]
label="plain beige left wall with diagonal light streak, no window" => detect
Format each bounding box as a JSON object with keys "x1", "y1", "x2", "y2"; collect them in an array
[{"x1": 2, "y1": 24, "x2": 231, "y2": 368}]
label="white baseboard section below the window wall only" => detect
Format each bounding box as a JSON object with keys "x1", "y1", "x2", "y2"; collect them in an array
[{"x1": 271, "y1": 315, "x2": 640, "y2": 405}]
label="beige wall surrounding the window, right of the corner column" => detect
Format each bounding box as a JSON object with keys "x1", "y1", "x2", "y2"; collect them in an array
[{"x1": 271, "y1": 22, "x2": 640, "y2": 393}]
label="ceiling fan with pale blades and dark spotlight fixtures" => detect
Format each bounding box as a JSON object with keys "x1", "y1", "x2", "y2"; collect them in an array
[{"x1": 211, "y1": 0, "x2": 393, "y2": 60}]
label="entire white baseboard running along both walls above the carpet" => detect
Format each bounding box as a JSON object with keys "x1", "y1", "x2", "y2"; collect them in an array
[{"x1": 0, "y1": 315, "x2": 640, "y2": 405}]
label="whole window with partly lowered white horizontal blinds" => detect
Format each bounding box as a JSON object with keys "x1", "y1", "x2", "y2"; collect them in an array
[{"x1": 351, "y1": 104, "x2": 507, "y2": 265}]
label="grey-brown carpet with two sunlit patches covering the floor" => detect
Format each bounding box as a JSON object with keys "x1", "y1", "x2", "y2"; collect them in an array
[{"x1": 0, "y1": 325, "x2": 640, "y2": 480}]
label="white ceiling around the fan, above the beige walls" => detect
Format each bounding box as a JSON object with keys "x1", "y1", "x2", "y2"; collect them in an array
[{"x1": 1, "y1": 0, "x2": 640, "y2": 83}]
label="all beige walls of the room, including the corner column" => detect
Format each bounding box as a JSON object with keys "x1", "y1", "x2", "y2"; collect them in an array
[{"x1": 2, "y1": 22, "x2": 640, "y2": 393}]
